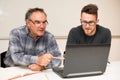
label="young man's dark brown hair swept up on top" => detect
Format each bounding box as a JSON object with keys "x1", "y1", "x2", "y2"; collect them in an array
[{"x1": 81, "y1": 4, "x2": 98, "y2": 18}]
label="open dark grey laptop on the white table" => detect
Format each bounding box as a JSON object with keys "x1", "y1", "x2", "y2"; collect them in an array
[{"x1": 53, "y1": 44, "x2": 110, "y2": 78}]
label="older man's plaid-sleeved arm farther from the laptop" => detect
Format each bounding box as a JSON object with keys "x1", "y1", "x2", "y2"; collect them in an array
[{"x1": 9, "y1": 30, "x2": 37, "y2": 66}]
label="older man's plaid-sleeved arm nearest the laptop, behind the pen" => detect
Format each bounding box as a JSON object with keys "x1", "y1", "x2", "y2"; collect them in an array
[{"x1": 45, "y1": 36, "x2": 61, "y2": 68}]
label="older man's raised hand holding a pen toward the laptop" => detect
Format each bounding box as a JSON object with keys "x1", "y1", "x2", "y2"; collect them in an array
[{"x1": 37, "y1": 53, "x2": 53, "y2": 66}]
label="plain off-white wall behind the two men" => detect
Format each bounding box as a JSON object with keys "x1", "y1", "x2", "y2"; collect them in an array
[{"x1": 0, "y1": 0, "x2": 120, "y2": 60}]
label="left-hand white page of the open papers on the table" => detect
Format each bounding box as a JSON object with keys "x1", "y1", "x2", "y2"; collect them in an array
[{"x1": 0, "y1": 67, "x2": 39, "y2": 80}]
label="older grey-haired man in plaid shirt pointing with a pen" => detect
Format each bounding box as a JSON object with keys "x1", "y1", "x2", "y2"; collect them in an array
[{"x1": 4, "y1": 8, "x2": 61, "y2": 71}]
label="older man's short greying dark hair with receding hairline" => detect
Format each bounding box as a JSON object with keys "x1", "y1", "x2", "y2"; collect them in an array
[{"x1": 25, "y1": 8, "x2": 47, "y2": 20}]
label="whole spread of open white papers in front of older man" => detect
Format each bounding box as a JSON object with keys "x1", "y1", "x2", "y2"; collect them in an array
[{"x1": 0, "y1": 67, "x2": 54, "y2": 80}]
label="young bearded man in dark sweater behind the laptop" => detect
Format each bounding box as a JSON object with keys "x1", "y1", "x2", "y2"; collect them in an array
[{"x1": 67, "y1": 4, "x2": 111, "y2": 44}]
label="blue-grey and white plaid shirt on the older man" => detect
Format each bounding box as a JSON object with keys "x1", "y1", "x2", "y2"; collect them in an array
[{"x1": 4, "y1": 25, "x2": 61, "y2": 68}]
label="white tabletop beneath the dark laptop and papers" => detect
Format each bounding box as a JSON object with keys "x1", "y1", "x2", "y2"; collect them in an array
[{"x1": 0, "y1": 61, "x2": 120, "y2": 80}]
